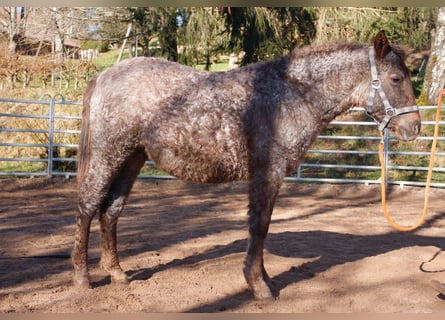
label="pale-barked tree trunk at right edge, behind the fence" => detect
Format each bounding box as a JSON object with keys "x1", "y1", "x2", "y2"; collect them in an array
[{"x1": 423, "y1": 7, "x2": 445, "y2": 104}]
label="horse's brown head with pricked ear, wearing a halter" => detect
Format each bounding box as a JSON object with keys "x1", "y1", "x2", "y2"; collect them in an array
[{"x1": 367, "y1": 31, "x2": 420, "y2": 141}]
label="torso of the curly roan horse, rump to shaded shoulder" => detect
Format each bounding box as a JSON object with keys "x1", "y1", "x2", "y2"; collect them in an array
[{"x1": 86, "y1": 58, "x2": 248, "y2": 182}]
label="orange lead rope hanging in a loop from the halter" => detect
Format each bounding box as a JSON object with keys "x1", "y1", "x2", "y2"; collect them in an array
[{"x1": 379, "y1": 89, "x2": 445, "y2": 232}]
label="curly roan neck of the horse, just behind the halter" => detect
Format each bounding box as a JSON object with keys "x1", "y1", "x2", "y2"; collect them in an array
[{"x1": 289, "y1": 46, "x2": 371, "y2": 122}]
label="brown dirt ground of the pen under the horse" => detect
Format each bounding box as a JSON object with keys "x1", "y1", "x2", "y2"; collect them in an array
[{"x1": 0, "y1": 179, "x2": 445, "y2": 313}]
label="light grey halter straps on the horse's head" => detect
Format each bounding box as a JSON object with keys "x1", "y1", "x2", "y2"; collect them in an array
[{"x1": 366, "y1": 47, "x2": 419, "y2": 131}]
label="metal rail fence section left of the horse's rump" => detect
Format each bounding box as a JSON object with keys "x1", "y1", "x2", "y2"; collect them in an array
[{"x1": 0, "y1": 95, "x2": 82, "y2": 177}]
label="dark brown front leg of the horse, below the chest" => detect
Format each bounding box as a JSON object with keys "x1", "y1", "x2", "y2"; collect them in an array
[{"x1": 244, "y1": 172, "x2": 282, "y2": 299}]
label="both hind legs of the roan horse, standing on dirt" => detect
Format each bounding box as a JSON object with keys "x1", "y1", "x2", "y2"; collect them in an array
[{"x1": 71, "y1": 149, "x2": 145, "y2": 288}]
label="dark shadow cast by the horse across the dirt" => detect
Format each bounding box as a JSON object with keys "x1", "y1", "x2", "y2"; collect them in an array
[{"x1": 114, "y1": 219, "x2": 445, "y2": 312}]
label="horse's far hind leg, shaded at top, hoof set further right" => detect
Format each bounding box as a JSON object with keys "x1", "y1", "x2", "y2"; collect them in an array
[{"x1": 99, "y1": 150, "x2": 147, "y2": 283}]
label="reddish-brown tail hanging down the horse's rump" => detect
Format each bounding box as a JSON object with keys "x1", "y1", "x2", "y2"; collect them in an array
[{"x1": 77, "y1": 77, "x2": 96, "y2": 186}]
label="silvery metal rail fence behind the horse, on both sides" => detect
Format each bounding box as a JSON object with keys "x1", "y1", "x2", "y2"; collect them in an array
[{"x1": 0, "y1": 95, "x2": 445, "y2": 187}]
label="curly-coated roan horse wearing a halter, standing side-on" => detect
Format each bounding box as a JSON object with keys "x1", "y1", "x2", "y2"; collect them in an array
[{"x1": 72, "y1": 32, "x2": 420, "y2": 298}]
